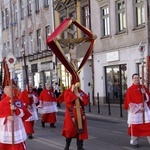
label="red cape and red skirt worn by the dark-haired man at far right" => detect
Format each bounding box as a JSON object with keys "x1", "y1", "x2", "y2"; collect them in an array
[{"x1": 124, "y1": 84, "x2": 150, "y2": 136}]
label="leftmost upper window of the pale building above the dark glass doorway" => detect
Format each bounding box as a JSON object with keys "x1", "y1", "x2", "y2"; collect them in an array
[{"x1": 101, "y1": 5, "x2": 110, "y2": 36}]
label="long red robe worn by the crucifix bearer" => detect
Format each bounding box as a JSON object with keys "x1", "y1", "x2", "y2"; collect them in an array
[{"x1": 62, "y1": 89, "x2": 88, "y2": 140}]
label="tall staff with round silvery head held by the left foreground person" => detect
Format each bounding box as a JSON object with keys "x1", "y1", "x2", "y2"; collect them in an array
[{"x1": 6, "y1": 53, "x2": 16, "y2": 144}]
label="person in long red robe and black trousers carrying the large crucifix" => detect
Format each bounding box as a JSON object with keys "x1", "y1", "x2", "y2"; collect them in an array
[{"x1": 57, "y1": 84, "x2": 89, "y2": 150}]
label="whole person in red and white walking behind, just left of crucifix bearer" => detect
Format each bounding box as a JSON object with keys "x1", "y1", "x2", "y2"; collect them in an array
[{"x1": 38, "y1": 84, "x2": 57, "y2": 128}]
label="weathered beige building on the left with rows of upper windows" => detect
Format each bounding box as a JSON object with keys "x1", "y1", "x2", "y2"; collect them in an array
[{"x1": 0, "y1": 0, "x2": 57, "y2": 89}]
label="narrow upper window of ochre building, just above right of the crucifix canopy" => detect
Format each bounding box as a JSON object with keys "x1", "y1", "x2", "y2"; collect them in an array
[{"x1": 82, "y1": 6, "x2": 89, "y2": 28}]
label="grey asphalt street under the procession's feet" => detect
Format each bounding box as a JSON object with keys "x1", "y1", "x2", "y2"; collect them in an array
[{"x1": 26, "y1": 113, "x2": 150, "y2": 150}]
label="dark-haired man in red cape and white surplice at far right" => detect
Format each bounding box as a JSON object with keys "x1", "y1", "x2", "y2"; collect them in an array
[{"x1": 124, "y1": 73, "x2": 150, "y2": 147}]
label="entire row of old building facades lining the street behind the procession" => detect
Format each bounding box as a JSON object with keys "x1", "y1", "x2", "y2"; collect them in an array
[{"x1": 0, "y1": 0, "x2": 150, "y2": 104}]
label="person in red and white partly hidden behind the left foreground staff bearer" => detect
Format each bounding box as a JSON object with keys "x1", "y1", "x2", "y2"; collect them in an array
[{"x1": 19, "y1": 84, "x2": 38, "y2": 139}]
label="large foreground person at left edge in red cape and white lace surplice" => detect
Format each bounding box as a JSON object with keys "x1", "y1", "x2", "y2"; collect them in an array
[{"x1": 0, "y1": 86, "x2": 31, "y2": 150}]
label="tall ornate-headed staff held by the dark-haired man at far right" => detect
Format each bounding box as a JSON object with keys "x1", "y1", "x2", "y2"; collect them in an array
[{"x1": 138, "y1": 42, "x2": 145, "y2": 123}]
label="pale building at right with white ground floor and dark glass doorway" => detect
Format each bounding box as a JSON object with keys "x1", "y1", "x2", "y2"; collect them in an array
[{"x1": 91, "y1": 0, "x2": 150, "y2": 103}]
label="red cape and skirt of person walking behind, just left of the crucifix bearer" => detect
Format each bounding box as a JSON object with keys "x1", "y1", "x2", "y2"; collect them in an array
[{"x1": 39, "y1": 89, "x2": 57, "y2": 124}]
